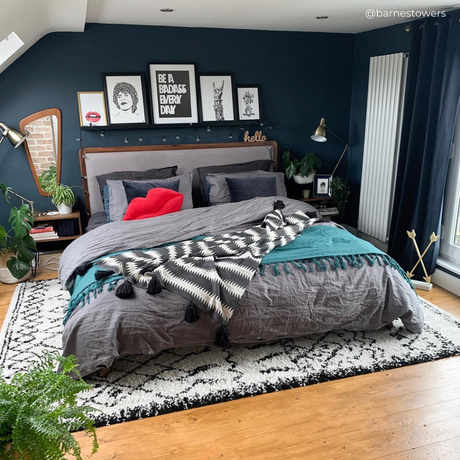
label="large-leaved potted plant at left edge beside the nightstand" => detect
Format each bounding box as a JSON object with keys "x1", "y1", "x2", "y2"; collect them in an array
[{"x1": 0, "y1": 183, "x2": 36, "y2": 284}]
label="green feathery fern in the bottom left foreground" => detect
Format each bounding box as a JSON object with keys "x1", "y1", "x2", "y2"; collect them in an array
[{"x1": 0, "y1": 353, "x2": 99, "y2": 460}]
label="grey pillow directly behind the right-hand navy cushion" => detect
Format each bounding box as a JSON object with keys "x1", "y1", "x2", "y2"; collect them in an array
[{"x1": 206, "y1": 171, "x2": 287, "y2": 206}]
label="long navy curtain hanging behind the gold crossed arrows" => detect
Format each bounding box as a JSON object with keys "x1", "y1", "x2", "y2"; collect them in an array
[{"x1": 388, "y1": 11, "x2": 460, "y2": 279}]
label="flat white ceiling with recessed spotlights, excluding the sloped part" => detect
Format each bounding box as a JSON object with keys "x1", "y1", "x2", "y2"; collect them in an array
[{"x1": 86, "y1": 0, "x2": 459, "y2": 33}]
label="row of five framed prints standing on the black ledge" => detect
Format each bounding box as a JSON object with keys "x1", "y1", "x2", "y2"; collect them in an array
[{"x1": 77, "y1": 63, "x2": 262, "y2": 129}]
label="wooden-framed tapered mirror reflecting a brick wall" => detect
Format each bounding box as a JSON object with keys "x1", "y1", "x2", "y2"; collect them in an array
[{"x1": 19, "y1": 108, "x2": 62, "y2": 196}]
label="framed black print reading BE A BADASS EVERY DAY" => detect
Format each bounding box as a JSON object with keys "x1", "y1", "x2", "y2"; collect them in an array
[{"x1": 149, "y1": 64, "x2": 198, "y2": 125}]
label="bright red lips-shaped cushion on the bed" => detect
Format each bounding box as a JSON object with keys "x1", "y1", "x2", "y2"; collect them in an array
[{"x1": 123, "y1": 188, "x2": 184, "y2": 220}]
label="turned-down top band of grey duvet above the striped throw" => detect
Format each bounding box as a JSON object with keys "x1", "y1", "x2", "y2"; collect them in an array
[{"x1": 59, "y1": 197, "x2": 315, "y2": 289}]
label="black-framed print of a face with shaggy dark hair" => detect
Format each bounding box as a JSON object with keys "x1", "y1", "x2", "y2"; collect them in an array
[{"x1": 102, "y1": 73, "x2": 148, "y2": 125}]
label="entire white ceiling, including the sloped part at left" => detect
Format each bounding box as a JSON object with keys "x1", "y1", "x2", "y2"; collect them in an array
[{"x1": 0, "y1": 0, "x2": 460, "y2": 73}]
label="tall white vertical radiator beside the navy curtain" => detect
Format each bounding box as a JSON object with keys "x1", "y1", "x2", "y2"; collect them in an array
[{"x1": 358, "y1": 53, "x2": 408, "y2": 242}]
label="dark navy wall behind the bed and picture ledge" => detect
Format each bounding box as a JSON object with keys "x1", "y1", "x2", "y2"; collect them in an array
[{"x1": 0, "y1": 24, "x2": 354, "y2": 222}]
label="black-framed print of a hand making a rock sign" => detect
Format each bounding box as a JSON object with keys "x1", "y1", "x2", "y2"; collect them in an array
[{"x1": 200, "y1": 74, "x2": 236, "y2": 123}]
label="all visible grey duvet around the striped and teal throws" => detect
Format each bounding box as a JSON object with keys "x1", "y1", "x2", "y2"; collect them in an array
[{"x1": 59, "y1": 197, "x2": 424, "y2": 376}]
